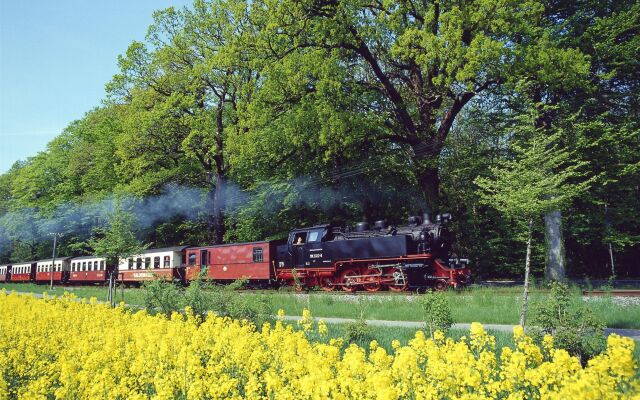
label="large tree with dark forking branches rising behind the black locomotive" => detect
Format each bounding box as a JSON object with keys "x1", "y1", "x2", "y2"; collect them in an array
[{"x1": 260, "y1": 0, "x2": 582, "y2": 211}]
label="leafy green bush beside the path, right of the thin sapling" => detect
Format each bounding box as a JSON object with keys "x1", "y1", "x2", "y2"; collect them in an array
[{"x1": 531, "y1": 282, "x2": 606, "y2": 363}]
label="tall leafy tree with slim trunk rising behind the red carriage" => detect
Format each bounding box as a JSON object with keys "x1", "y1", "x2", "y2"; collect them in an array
[{"x1": 109, "y1": 0, "x2": 257, "y2": 243}]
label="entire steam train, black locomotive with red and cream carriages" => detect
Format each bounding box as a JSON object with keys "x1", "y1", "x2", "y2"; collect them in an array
[{"x1": 0, "y1": 213, "x2": 471, "y2": 292}]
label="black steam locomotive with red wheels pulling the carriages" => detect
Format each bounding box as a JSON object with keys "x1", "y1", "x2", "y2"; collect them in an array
[{"x1": 276, "y1": 214, "x2": 469, "y2": 291}]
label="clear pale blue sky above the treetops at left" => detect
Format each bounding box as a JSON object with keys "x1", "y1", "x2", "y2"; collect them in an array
[{"x1": 0, "y1": 0, "x2": 191, "y2": 173}]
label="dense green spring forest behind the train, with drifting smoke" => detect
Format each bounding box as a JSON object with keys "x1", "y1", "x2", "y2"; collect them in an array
[{"x1": 0, "y1": 0, "x2": 640, "y2": 278}]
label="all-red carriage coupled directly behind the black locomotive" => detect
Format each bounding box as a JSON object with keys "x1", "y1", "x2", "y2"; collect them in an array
[{"x1": 187, "y1": 240, "x2": 281, "y2": 284}]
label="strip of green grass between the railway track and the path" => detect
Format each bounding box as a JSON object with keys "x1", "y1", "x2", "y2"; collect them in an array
[{"x1": 0, "y1": 284, "x2": 640, "y2": 328}]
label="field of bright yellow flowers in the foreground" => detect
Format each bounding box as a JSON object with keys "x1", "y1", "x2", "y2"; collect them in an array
[{"x1": 0, "y1": 292, "x2": 640, "y2": 399}]
